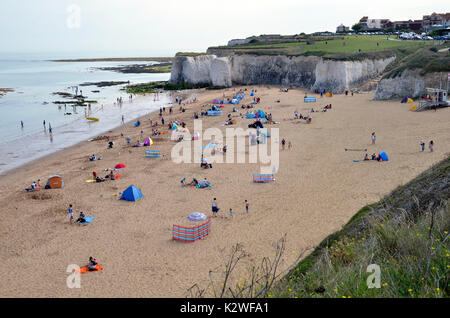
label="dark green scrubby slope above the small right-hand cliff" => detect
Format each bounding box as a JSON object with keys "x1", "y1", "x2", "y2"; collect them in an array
[{"x1": 384, "y1": 46, "x2": 450, "y2": 78}]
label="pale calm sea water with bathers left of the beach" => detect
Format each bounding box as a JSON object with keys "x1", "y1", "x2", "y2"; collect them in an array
[{"x1": 0, "y1": 54, "x2": 171, "y2": 174}]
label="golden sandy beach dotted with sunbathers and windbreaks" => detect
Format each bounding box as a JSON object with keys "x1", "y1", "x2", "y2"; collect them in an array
[{"x1": 0, "y1": 86, "x2": 450, "y2": 297}]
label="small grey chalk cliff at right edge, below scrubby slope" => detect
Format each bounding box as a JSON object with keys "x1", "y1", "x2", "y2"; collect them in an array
[{"x1": 374, "y1": 69, "x2": 445, "y2": 100}]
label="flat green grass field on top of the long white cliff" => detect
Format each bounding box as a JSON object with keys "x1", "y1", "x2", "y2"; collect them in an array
[{"x1": 210, "y1": 35, "x2": 434, "y2": 60}]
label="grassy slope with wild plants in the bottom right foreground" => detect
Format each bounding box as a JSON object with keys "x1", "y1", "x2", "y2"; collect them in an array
[{"x1": 271, "y1": 157, "x2": 450, "y2": 298}]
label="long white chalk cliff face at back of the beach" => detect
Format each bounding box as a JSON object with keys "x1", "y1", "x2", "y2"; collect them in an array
[{"x1": 170, "y1": 54, "x2": 395, "y2": 93}]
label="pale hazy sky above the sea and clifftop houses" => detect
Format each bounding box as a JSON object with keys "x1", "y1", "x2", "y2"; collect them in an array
[{"x1": 0, "y1": 0, "x2": 450, "y2": 57}]
